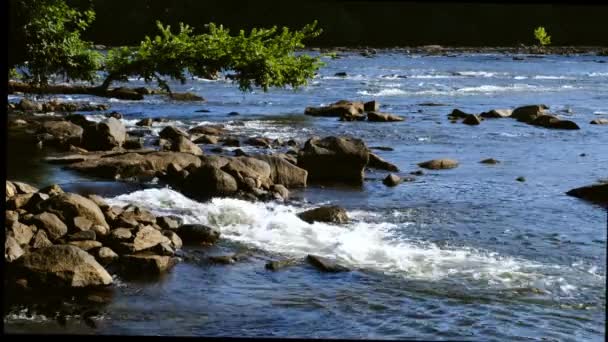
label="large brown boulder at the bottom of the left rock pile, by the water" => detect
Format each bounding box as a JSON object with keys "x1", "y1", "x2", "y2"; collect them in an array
[{"x1": 18, "y1": 245, "x2": 112, "y2": 287}]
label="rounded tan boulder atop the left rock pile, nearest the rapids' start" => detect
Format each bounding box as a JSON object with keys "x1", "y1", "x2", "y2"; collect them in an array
[{"x1": 40, "y1": 193, "x2": 109, "y2": 227}]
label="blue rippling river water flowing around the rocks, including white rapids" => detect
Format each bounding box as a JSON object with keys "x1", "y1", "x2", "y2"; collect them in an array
[{"x1": 4, "y1": 51, "x2": 608, "y2": 341}]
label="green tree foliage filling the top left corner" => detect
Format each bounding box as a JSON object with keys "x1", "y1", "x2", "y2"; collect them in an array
[{"x1": 14, "y1": 0, "x2": 102, "y2": 86}]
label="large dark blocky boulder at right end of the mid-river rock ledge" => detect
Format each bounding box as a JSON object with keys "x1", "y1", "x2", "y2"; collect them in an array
[{"x1": 298, "y1": 136, "x2": 369, "y2": 185}]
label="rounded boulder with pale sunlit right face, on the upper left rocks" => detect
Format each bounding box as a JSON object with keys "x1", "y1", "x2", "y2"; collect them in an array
[{"x1": 82, "y1": 118, "x2": 127, "y2": 151}]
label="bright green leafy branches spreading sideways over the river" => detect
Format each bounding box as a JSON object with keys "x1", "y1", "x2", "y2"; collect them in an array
[{"x1": 103, "y1": 21, "x2": 322, "y2": 91}]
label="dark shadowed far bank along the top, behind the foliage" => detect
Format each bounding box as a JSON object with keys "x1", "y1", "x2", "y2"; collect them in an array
[{"x1": 61, "y1": 0, "x2": 608, "y2": 47}]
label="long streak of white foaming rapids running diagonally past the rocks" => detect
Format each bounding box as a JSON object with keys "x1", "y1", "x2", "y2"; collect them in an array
[{"x1": 108, "y1": 188, "x2": 600, "y2": 291}]
